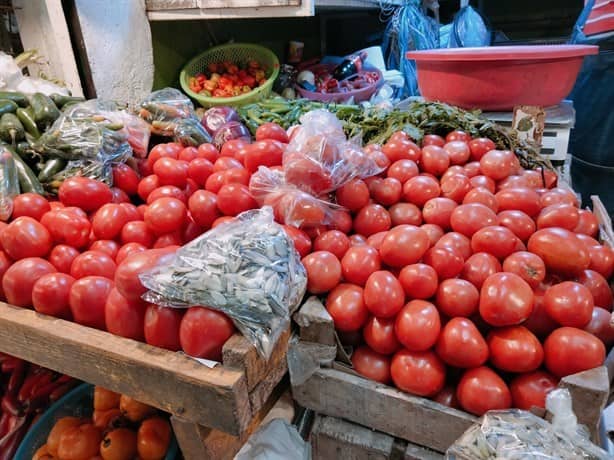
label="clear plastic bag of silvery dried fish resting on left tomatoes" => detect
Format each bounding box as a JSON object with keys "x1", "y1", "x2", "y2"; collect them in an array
[{"x1": 139, "y1": 206, "x2": 307, "y2": 358}]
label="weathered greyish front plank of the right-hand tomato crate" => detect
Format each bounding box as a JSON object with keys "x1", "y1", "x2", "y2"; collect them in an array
[{"x1": 292, "y1": 369, "x2": 476, "y2": 452}]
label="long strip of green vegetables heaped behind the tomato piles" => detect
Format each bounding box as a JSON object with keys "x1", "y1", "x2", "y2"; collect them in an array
[{"x1": 239, "y1": 98, "x2": 552, "y2": 169}]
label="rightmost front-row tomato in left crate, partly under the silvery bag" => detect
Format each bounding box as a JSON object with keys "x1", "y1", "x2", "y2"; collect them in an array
[{"x1": 179, "y1": 307, "x2": 235, "y2": 362}]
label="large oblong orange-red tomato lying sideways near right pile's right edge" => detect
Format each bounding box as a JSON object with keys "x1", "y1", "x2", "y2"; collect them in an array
[{"x1": 527, "y1": 228, "x2": 591, "y2": 276}]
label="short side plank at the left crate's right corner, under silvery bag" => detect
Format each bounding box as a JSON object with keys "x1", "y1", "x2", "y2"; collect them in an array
[{"x1": 222, "y1": 328, "x2": 290, "y2": 391}]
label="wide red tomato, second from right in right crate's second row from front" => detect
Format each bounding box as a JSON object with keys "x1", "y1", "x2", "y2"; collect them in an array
[{"x1": 487, "y1": 326, "x2": 544, "y2": 372}]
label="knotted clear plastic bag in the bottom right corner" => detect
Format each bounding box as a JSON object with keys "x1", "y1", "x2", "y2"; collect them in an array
[{"x1": 446, "y1": 389, "x2": 611, "y2": 460}]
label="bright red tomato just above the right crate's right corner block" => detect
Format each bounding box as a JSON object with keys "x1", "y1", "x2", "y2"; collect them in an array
[{"x1": 544, "y1": 327, "x2": 605, "y2": 377}]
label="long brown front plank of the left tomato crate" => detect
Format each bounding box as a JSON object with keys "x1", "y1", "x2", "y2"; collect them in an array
[{"x1": 0, "y1": 303, "x2": 252, "y2": 434}]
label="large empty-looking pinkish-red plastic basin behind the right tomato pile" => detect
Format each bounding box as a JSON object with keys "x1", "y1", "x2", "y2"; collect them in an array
[{"x1": 406, "y1": 45, "x2": 599, "y2": 111}]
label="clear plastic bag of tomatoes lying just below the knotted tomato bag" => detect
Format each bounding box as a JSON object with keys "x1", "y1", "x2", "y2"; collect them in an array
[{"x1": 249, "y1": 166, "x2": 343, "y2": 228}]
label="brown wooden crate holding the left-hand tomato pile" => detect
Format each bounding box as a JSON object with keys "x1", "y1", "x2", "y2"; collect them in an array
[{"x1": 0, "y1": 302, "x2": 290, "y2": 460}]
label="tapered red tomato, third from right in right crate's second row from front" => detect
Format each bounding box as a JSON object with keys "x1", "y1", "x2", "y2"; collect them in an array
[{"x1": 435, "y1": 318, "x2": 488, "y2": 368}]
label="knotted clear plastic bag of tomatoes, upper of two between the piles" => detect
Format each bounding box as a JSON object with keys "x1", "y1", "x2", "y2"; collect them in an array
[{"x1": 283, "y1": 110, "x2": 383, "y2": 196}]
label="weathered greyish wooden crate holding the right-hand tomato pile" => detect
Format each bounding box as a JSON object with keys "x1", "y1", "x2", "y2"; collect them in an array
[{"x1": 289, "y1": 297, "x2": 614, "y2": 452}]
